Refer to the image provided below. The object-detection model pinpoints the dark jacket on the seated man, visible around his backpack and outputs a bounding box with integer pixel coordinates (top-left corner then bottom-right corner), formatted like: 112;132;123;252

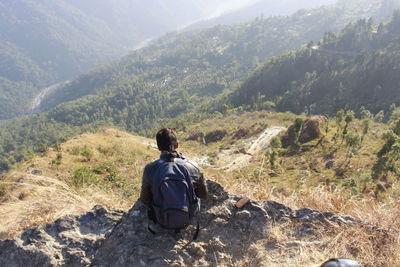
139;151;208;206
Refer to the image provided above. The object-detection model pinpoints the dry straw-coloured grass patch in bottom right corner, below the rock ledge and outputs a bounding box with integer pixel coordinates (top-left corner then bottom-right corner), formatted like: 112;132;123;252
238;223;399;267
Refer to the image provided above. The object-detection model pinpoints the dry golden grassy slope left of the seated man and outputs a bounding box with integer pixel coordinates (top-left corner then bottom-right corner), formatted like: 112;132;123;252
0;129;158;239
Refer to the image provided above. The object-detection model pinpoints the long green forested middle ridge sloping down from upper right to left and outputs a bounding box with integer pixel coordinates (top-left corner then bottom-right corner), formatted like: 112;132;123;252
0;0;398;172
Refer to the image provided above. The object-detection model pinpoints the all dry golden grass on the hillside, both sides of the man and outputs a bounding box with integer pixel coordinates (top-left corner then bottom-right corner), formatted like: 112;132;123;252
0;112;400;266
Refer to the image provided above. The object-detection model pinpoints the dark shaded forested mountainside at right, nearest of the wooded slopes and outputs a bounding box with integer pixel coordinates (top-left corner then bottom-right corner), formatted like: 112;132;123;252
228;11;400;114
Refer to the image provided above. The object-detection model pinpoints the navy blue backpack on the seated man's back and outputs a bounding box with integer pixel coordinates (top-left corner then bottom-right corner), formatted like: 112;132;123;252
152;158;200;230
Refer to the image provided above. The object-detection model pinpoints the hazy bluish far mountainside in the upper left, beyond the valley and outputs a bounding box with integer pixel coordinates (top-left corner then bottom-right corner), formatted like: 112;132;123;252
0;0;230;119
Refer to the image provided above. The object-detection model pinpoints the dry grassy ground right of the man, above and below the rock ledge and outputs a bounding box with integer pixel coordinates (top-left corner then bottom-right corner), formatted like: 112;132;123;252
191;112;400;266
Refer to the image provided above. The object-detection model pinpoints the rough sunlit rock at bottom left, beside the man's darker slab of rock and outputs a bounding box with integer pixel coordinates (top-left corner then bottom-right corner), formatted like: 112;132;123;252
0;206;123;267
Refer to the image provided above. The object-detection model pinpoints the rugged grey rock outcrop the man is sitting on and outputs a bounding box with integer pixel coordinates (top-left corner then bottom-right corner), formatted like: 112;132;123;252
0;181;356;266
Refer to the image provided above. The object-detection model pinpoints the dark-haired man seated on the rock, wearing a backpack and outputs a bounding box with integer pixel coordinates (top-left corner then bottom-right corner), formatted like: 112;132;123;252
140;128;207;231
